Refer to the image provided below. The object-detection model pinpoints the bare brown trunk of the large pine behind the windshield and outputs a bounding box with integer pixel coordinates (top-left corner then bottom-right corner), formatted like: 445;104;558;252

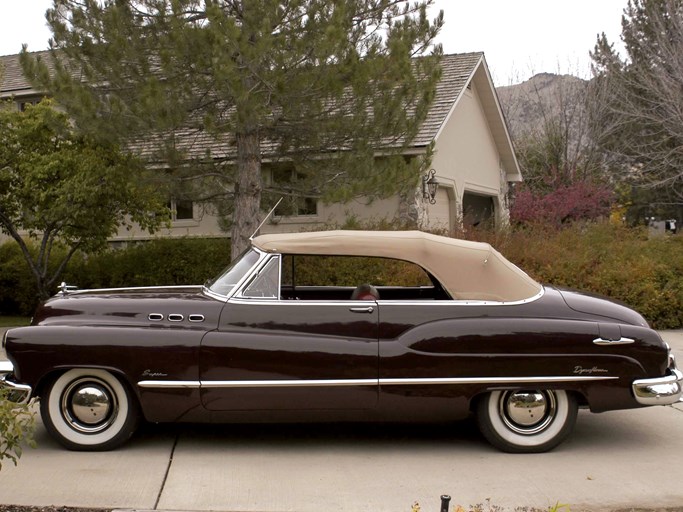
230;130;263;260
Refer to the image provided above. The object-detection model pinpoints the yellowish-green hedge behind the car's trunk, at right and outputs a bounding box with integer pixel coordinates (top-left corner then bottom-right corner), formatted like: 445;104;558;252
473;222;683;329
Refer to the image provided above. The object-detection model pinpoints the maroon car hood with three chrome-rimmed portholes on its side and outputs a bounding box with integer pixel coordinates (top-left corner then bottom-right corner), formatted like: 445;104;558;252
33;286;223;325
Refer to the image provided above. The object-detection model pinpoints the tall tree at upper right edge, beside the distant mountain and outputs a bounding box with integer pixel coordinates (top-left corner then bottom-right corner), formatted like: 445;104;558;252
591;0;683;215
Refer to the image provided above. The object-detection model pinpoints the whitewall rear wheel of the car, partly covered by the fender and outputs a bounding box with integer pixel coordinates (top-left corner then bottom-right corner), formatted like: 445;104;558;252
476;390;578;453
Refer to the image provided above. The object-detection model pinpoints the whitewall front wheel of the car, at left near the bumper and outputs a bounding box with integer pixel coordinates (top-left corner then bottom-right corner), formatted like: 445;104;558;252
40;368;139;451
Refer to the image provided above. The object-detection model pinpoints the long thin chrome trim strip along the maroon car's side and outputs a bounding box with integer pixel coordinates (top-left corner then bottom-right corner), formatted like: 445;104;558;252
138;375;619;389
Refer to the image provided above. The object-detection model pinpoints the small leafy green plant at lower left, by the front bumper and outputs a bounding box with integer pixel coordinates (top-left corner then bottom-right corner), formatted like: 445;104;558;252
0;389;35;469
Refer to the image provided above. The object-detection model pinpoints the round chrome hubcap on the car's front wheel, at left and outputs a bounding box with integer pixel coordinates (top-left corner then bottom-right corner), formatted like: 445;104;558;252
61;377;118;434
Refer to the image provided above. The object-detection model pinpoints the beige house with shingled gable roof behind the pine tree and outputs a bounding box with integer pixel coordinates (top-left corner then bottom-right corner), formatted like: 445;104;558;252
0;52;522;241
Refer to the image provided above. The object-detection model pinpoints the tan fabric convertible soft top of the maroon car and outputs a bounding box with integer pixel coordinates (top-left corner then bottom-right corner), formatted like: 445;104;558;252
252;231;542;302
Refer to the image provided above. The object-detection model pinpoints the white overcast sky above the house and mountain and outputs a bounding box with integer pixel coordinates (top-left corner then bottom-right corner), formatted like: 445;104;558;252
0;0;627;85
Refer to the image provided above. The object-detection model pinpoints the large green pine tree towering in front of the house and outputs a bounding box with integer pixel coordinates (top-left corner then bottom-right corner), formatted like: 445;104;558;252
22;0;443;256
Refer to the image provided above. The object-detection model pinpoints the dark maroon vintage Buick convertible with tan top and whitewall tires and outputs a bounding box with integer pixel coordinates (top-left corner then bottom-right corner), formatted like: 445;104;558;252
0;231;683;452
